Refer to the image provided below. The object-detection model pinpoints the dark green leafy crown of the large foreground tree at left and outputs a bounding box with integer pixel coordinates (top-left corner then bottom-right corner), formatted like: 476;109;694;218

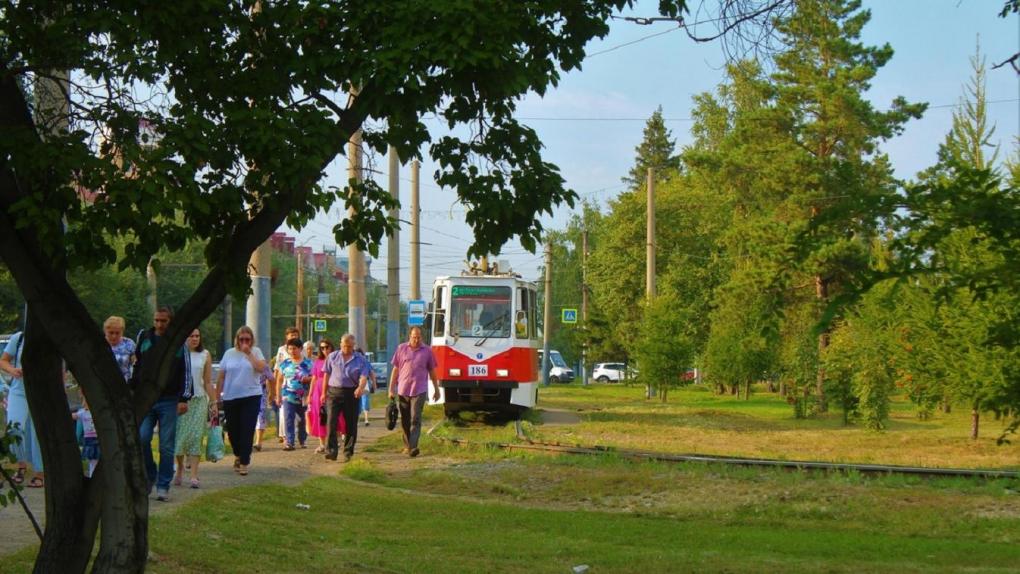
0;0;683;295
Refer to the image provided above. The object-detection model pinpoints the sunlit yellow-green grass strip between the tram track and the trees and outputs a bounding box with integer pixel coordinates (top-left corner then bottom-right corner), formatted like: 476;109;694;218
514;384;1020;470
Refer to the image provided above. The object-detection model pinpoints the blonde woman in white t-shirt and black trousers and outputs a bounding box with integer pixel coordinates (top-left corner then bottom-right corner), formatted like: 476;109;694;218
216;325;266;476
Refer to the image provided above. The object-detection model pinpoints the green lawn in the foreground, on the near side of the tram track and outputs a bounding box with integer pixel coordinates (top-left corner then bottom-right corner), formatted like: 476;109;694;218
0;448;1020;574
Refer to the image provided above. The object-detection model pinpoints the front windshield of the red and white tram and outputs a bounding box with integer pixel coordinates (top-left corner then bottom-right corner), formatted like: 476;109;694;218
450;285;512;338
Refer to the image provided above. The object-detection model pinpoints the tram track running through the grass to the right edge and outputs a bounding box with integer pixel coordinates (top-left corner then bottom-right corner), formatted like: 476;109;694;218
427;419;1020;479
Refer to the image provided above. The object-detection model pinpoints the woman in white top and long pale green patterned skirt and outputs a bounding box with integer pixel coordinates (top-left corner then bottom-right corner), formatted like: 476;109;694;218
173;329;216;488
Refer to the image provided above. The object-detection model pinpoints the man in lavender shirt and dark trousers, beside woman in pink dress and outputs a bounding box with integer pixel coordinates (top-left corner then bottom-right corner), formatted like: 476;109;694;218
320;333;372;462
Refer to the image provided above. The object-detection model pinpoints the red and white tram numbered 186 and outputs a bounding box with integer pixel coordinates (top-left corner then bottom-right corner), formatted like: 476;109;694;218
430;272;539;416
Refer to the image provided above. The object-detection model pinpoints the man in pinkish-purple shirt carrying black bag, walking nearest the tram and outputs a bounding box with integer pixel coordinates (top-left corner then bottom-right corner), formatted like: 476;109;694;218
390;327;440;457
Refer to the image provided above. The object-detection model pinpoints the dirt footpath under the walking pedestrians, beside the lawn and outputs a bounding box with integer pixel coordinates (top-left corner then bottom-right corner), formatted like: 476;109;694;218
0;405;579;557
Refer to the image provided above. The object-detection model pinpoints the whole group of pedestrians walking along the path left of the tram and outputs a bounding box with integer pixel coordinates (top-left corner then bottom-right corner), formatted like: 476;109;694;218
0;314;440;501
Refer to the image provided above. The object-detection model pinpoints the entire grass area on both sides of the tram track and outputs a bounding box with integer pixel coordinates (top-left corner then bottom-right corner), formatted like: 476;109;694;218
7;385;1020;574
